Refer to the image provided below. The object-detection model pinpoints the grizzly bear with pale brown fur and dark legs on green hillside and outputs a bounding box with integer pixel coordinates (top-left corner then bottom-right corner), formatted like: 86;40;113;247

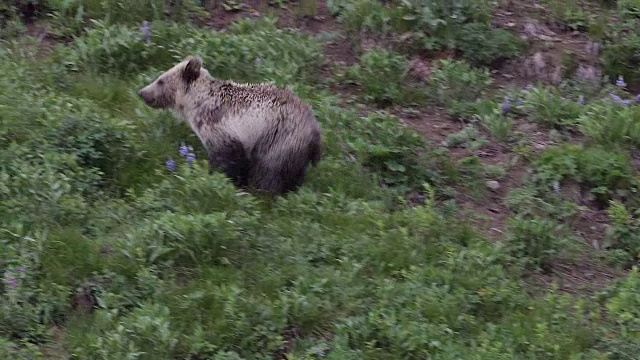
139;56;323;195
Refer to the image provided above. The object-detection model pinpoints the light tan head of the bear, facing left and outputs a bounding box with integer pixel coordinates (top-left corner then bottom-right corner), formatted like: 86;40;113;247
138;56;206;109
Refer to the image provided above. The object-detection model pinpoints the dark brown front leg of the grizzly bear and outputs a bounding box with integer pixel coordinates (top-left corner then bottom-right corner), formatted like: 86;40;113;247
208;138;250;188
